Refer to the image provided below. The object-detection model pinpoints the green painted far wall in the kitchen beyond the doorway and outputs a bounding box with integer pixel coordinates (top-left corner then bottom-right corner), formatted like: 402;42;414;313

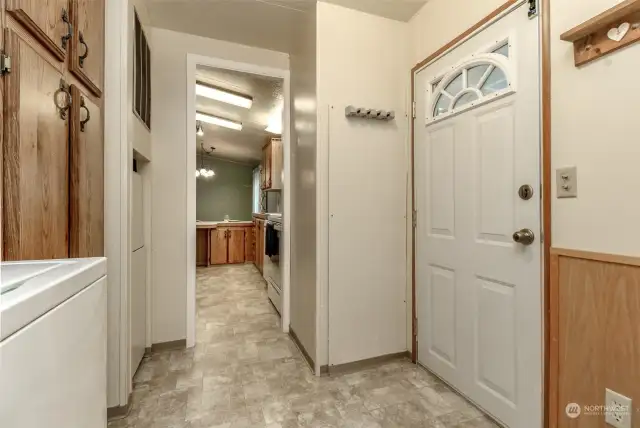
196;157;253;221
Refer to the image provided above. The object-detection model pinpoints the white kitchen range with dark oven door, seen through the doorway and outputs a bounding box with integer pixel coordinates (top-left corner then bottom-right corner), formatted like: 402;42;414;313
264;214;284;314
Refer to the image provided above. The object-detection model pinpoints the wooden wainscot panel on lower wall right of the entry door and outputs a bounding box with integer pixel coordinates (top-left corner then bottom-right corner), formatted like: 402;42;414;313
549;250;640;428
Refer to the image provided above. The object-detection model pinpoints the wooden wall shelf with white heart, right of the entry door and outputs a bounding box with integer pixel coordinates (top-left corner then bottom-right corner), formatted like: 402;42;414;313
560;0;640;67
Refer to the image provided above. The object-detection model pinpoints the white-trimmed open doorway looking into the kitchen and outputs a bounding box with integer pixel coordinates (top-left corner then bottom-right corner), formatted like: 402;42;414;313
185;54;291;347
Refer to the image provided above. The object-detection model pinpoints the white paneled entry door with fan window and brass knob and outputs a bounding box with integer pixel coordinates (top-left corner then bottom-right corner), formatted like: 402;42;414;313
414;3;543;428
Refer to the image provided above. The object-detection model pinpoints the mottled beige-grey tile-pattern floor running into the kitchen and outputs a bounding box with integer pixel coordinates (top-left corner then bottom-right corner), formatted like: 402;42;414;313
109;265;496;428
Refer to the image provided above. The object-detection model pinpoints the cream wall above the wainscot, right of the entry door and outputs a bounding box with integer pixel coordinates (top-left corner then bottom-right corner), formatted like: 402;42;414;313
551;0;640;256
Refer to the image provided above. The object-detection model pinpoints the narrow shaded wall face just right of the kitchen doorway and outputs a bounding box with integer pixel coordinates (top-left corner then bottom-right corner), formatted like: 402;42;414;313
290;8;318;363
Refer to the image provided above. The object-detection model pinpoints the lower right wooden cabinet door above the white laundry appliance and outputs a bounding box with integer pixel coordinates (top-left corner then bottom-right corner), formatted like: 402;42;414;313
69;85;104;257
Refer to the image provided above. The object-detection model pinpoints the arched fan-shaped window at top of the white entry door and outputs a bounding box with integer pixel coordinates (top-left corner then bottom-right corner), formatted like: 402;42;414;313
427;41;515;123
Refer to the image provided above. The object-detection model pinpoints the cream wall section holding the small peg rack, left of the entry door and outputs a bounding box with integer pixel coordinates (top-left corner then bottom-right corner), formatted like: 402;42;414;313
317;2;410;365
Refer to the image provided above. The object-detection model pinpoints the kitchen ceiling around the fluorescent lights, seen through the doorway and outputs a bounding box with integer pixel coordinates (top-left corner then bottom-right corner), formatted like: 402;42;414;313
196;67;284;165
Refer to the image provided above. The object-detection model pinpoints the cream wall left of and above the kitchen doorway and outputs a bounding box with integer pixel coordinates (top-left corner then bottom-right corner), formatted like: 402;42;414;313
148;28;289;343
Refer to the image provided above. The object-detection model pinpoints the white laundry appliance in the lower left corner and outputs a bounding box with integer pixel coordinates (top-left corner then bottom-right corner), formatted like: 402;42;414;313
0;257;107;428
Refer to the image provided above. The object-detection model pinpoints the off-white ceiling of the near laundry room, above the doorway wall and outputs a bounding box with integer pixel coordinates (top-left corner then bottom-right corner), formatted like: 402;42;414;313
147;0;426;52
